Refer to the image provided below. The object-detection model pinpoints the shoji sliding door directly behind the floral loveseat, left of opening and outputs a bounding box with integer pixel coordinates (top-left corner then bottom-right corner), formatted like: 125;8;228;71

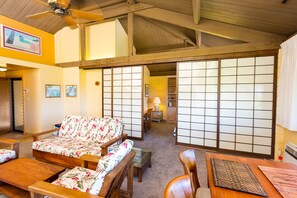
103;66;143;138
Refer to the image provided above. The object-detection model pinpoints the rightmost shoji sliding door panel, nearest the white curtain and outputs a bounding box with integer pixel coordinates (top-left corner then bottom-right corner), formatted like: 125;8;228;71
219;56;274;155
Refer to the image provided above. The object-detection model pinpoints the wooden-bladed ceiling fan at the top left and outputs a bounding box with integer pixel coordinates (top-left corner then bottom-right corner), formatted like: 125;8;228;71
26;0;104;29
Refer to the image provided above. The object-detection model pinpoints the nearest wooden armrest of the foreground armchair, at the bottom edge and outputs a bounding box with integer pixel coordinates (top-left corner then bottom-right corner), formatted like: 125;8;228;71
28;181;101;198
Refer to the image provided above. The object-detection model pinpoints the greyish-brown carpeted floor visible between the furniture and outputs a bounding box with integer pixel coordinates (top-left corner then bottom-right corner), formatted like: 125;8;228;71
0;122;207;198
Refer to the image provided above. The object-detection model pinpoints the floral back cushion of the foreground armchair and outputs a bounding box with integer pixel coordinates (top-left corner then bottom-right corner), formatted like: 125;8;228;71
90;139;134;195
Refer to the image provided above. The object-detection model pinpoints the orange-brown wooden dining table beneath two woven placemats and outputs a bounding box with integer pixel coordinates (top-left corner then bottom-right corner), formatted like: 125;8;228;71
205;152;297;198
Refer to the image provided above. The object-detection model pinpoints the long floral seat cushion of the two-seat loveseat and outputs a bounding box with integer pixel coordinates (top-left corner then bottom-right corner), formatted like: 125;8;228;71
32;137;101;158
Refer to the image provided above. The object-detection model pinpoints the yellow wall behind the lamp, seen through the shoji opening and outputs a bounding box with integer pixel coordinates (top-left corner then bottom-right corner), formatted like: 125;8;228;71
149;76;168;119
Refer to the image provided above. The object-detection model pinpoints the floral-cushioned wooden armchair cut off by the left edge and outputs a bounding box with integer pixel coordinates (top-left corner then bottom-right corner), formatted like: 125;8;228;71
0;138;20;164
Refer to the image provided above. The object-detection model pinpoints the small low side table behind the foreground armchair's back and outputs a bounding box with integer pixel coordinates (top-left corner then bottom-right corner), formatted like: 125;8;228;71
133;148;152;183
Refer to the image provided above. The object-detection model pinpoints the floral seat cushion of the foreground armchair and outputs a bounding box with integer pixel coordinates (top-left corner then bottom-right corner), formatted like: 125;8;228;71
52;167;95;192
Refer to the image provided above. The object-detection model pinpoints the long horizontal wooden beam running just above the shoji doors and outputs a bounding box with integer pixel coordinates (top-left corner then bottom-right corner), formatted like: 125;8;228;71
57;42;280;69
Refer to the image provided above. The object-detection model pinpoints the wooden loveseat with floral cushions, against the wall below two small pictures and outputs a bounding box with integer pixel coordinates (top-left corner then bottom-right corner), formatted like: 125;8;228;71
32;115;126;168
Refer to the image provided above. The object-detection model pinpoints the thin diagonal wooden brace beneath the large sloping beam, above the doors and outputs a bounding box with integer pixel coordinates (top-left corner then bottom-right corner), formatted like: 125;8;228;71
145;18;196;46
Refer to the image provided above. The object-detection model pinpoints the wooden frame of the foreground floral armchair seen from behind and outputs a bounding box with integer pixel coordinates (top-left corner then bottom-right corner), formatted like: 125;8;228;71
28;150;136;198
